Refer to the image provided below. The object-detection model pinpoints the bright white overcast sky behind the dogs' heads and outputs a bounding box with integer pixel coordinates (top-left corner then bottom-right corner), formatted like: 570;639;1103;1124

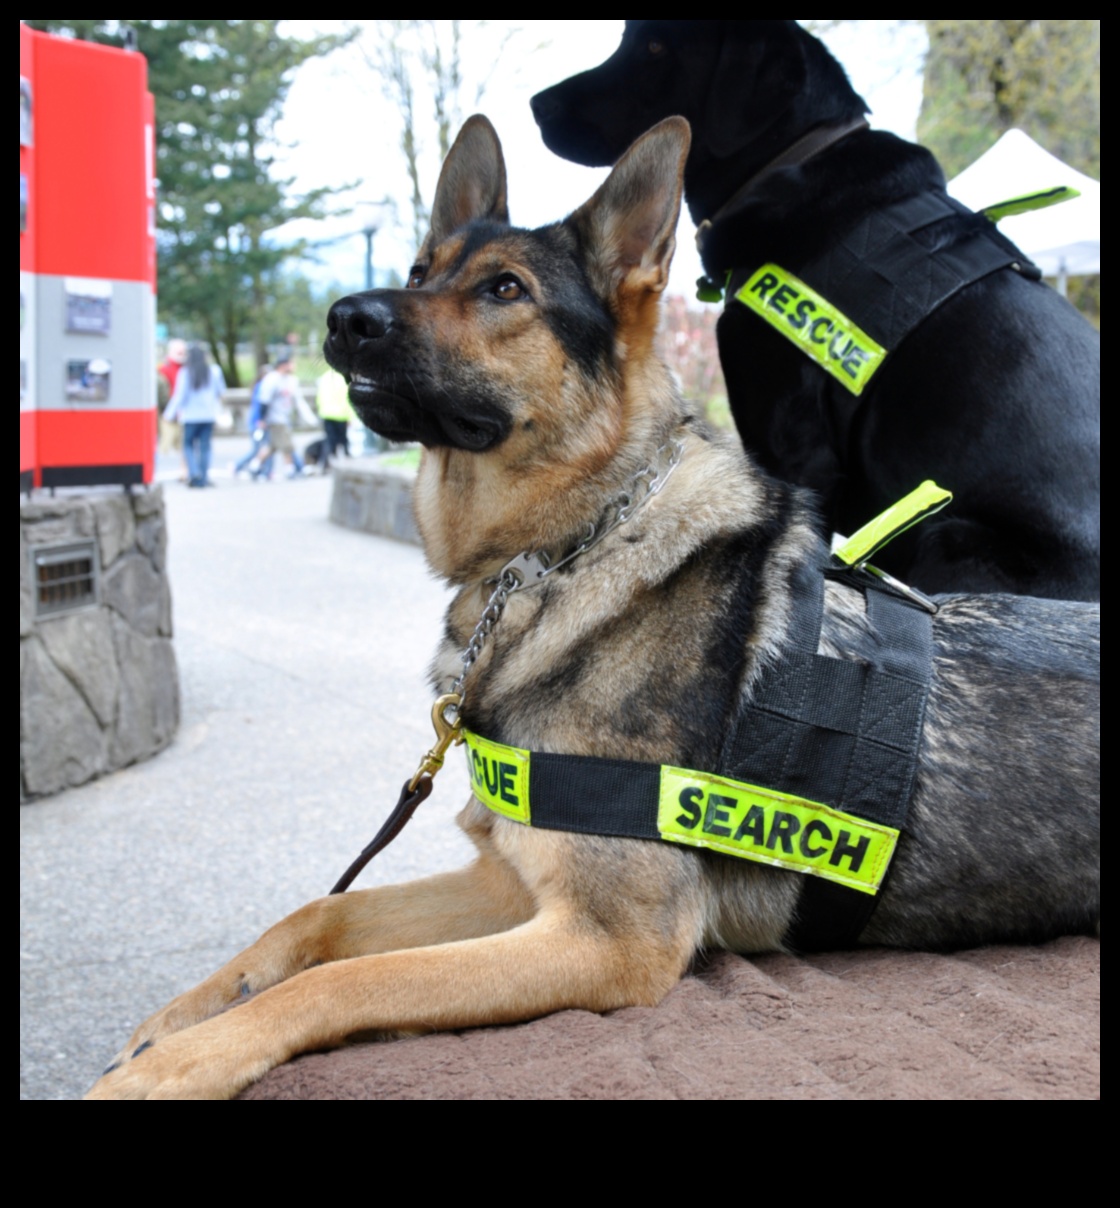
277;21;925;296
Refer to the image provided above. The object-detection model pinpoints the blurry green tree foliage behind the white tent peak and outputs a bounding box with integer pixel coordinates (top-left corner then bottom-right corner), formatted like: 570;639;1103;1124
918;21;1101;326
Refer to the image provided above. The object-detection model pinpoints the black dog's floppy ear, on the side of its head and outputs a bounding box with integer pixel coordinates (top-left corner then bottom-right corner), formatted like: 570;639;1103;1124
704;21;808;158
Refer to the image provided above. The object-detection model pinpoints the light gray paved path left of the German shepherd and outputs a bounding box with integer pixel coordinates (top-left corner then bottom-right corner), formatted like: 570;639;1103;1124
19;439;470;1099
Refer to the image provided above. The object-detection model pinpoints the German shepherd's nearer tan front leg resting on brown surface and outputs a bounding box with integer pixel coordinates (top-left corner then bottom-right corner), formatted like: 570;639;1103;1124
88;905;692;1099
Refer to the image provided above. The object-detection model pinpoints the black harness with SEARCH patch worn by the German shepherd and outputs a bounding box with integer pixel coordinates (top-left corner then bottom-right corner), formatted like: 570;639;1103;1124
464;484;948;951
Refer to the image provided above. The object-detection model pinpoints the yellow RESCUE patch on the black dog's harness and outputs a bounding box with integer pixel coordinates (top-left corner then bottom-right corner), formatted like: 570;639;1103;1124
735;265;887;395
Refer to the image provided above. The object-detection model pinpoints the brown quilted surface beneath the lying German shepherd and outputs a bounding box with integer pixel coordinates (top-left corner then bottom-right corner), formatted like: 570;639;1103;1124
242;936;1101;1099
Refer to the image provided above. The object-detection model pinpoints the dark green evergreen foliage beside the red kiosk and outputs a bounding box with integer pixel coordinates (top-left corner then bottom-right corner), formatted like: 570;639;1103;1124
28;21;347;385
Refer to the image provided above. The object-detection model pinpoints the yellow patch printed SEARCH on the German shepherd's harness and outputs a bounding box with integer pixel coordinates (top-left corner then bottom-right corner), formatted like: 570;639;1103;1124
657;767;899;894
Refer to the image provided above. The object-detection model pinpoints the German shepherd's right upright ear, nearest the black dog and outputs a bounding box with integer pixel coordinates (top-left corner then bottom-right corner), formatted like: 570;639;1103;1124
568;117;692;297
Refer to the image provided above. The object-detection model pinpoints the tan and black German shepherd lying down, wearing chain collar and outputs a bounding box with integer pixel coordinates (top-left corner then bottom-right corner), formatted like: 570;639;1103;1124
91;117;1099;1098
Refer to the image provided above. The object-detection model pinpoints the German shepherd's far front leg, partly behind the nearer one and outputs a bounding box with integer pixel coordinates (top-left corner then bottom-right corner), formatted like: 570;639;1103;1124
94;853;535;1070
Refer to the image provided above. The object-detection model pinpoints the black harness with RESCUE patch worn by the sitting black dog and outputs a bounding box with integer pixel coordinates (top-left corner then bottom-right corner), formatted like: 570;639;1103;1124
708;190;1064;395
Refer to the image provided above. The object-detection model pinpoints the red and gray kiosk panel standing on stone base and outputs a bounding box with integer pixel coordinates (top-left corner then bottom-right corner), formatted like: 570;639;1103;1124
19;25;156;490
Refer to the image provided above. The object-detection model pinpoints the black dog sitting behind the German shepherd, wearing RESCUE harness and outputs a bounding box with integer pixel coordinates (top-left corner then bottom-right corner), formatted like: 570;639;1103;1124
533;21;1101;599
